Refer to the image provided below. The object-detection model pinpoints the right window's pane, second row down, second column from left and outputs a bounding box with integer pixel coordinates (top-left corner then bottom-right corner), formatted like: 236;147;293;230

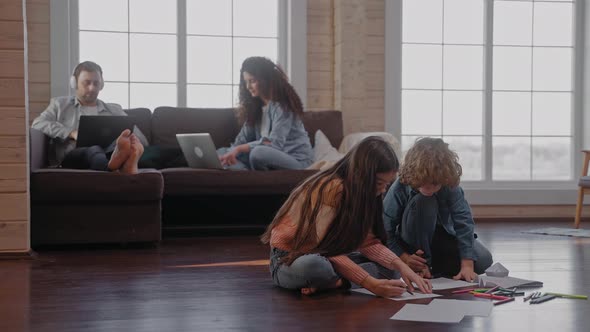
443;45;483;90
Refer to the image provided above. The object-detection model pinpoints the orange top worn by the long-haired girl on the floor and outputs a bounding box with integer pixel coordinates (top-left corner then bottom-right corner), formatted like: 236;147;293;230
270;180;399;285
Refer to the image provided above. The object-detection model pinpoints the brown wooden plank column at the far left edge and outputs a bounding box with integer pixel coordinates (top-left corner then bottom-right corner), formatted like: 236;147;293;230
0;0;30;253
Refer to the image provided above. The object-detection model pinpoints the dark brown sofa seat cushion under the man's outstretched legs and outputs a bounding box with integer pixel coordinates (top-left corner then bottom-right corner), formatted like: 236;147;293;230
31;168;164;203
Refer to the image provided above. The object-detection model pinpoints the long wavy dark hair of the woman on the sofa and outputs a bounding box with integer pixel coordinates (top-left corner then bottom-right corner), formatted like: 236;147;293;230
239;56;303;126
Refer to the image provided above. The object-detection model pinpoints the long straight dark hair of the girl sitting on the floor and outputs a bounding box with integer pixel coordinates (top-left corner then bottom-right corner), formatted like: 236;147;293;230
261;136;399;264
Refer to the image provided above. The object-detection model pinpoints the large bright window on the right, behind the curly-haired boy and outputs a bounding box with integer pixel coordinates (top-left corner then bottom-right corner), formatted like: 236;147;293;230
399;0;575;183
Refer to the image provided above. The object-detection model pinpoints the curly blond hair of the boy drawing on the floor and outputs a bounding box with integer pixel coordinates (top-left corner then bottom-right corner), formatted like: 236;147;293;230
399;137;463;189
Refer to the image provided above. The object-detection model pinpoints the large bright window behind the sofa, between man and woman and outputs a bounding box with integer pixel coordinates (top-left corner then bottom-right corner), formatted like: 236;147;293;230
78;0;279;110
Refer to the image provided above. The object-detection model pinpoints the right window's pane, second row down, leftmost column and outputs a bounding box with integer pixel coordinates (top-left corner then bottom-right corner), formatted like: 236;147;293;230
402;45;442;89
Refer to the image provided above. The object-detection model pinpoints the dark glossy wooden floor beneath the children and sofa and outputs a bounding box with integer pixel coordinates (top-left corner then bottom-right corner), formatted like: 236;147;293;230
0;222;590;332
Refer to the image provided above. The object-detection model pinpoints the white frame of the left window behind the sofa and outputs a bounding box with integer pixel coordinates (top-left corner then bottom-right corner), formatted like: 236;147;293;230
50;0;307;111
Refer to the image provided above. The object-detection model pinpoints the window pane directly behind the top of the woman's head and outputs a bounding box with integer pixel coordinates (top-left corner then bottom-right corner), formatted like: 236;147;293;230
232;38;278;84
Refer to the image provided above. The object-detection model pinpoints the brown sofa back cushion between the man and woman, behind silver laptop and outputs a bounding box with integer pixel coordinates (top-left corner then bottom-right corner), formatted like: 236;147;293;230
152;107;240;148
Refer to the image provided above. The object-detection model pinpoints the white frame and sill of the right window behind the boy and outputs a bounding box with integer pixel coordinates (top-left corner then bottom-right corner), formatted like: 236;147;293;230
385;0;590;205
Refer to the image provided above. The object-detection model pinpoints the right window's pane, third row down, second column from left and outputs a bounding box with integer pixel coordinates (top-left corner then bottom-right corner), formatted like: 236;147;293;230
443;91;483;135
